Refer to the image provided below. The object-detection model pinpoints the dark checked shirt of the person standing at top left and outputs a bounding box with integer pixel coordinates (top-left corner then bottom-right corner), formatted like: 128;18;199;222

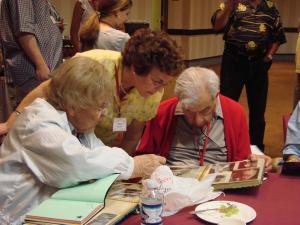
0;0;62;86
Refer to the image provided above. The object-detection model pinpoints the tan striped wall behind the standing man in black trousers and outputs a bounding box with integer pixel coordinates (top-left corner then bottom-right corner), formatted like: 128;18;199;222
168;0;300;60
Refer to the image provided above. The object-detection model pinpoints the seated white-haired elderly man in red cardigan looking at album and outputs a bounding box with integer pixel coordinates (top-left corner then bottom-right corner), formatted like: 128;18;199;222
134;67;272;170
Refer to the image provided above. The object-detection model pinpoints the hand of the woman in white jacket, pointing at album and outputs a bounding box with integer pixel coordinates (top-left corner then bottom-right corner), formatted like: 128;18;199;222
131;154;166;178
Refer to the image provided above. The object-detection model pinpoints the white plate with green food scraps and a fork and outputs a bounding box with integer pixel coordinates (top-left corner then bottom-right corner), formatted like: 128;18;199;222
195;201;256;224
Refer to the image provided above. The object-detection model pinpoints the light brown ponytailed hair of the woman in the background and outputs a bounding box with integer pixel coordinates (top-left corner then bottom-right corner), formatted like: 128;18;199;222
79;0;132;51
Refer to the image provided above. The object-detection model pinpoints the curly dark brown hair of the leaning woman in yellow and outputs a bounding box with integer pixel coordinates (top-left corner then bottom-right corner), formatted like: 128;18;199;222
122;28;185;76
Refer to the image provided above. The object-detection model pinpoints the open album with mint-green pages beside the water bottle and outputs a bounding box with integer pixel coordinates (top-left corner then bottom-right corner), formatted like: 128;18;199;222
25;174;142;225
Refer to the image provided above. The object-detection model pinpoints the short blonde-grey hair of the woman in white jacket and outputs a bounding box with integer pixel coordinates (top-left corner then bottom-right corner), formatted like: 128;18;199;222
45;56;113;111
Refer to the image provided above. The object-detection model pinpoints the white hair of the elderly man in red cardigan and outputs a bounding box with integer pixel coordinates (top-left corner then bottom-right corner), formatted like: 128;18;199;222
175;67;220;108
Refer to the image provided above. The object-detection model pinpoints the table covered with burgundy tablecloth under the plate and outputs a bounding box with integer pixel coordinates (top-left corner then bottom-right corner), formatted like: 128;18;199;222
120;173;300;225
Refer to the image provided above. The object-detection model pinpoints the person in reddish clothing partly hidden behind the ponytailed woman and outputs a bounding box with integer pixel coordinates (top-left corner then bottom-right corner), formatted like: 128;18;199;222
70;0;102;52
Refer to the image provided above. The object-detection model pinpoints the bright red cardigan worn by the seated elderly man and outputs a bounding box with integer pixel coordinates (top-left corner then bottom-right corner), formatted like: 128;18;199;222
134;95;251;161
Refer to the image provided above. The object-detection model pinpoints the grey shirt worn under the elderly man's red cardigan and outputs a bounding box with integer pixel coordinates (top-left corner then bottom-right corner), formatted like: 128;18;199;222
167;98;227;166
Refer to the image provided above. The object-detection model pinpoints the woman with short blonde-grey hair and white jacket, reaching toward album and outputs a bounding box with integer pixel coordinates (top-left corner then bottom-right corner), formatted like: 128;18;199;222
0;57;165;225
